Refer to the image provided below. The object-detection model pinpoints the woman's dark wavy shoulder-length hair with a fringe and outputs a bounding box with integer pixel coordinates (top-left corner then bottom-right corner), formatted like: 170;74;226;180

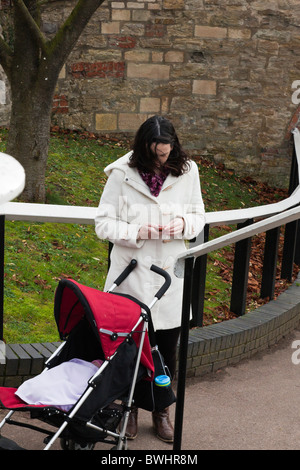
129;116;189;176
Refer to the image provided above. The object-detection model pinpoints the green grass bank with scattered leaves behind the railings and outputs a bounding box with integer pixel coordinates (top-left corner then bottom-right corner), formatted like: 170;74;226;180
0;129;286;343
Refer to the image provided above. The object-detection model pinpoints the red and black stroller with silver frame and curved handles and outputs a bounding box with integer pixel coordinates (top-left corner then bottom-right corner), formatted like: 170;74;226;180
0;260;171;450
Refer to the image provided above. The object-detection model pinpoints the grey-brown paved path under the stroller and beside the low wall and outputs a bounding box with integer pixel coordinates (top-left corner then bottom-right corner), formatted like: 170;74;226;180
0;330;300;451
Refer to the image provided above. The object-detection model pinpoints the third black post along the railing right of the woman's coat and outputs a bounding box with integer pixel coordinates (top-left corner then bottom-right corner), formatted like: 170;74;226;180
260;227;280;300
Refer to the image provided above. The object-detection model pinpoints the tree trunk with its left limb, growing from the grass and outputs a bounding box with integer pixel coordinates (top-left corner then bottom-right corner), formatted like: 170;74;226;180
6;1;57;203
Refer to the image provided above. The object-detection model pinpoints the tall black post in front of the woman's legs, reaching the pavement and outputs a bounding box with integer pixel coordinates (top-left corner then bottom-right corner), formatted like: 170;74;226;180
173;258;194;450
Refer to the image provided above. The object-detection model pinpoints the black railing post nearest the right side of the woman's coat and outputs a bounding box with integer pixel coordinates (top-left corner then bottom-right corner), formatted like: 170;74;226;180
191;224;209;326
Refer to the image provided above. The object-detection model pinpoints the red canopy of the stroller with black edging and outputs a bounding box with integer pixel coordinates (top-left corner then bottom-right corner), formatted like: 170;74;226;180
54;279;154;372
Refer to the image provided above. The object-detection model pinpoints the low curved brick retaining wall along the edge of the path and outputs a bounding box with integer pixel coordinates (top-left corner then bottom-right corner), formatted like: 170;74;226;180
0;273;300;387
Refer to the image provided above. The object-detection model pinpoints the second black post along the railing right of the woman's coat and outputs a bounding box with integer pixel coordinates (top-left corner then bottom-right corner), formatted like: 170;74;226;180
230;219;253;316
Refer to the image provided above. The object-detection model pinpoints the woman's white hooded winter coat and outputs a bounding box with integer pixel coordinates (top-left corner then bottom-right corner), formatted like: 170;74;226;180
95;152;205;330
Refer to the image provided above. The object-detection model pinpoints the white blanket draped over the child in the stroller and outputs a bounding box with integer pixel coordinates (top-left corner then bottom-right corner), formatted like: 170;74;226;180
16;359;98;411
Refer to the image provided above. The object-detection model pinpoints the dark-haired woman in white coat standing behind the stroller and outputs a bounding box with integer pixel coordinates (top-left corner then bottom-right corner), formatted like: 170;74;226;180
95;116;205;442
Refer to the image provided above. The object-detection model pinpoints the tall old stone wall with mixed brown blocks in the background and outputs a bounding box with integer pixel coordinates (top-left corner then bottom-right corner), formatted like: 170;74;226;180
0;0;300;185
